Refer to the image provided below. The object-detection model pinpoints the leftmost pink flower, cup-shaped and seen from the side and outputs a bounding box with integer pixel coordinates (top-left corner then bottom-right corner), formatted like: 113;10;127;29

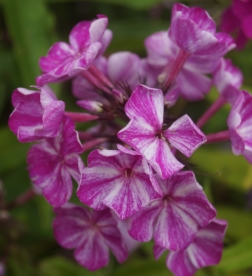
9;86;65;142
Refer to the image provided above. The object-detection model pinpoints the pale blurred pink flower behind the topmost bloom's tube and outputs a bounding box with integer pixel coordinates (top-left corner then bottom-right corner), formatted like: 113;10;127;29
145;31;218;100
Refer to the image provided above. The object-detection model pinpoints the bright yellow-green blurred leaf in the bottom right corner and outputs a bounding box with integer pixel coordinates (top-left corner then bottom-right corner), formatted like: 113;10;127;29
216;236;252;272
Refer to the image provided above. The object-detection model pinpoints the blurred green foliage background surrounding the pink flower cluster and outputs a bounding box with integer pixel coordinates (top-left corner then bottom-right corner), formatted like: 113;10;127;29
0;0;252;276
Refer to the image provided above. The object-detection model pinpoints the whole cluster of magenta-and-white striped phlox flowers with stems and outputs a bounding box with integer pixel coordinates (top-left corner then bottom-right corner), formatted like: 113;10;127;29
9;3;252;276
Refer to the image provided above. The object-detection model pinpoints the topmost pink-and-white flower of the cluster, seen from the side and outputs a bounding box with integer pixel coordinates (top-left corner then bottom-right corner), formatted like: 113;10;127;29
168;3;235;59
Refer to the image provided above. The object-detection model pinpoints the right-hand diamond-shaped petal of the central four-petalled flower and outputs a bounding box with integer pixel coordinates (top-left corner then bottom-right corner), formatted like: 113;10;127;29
164;115;206;157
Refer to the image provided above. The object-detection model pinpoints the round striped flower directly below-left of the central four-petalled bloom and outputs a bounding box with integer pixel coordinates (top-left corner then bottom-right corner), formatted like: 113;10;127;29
77;147;160;219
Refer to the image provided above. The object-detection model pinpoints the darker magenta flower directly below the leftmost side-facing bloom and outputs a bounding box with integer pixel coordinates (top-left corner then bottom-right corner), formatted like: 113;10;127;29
27;116;84;207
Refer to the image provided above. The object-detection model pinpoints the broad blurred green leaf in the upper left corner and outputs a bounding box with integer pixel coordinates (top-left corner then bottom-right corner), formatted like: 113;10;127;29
3;0;55;86
